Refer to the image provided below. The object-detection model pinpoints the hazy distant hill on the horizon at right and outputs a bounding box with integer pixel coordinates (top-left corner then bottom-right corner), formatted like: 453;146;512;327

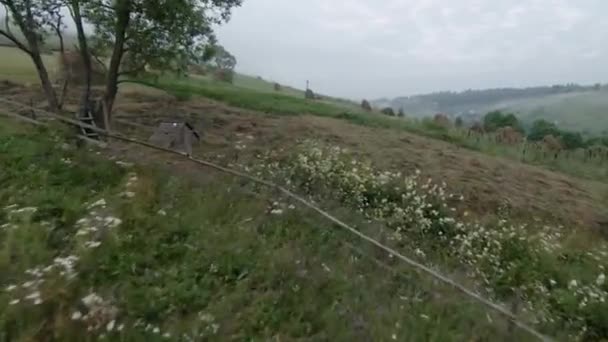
373;84;608;134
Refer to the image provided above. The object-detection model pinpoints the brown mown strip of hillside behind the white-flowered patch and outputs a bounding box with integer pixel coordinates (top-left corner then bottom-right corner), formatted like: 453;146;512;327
4;82;608;229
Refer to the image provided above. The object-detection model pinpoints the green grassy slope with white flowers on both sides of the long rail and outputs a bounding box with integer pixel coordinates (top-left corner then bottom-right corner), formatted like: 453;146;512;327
0;119;608;341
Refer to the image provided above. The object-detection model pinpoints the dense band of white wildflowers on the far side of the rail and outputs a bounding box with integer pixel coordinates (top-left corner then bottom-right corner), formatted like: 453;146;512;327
253;141;608;340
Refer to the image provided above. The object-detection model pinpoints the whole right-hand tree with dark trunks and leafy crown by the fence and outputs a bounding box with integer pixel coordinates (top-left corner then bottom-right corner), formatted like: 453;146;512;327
64;0;242;127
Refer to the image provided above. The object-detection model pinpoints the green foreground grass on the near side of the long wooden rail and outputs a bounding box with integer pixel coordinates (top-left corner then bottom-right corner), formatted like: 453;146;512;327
0;119;528;341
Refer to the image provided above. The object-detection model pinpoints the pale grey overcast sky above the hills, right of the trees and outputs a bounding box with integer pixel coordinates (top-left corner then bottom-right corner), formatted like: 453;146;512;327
218;0;608;99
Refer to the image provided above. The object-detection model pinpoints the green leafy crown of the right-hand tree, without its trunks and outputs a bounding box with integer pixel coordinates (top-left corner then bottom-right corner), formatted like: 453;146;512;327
82;0;242;74
